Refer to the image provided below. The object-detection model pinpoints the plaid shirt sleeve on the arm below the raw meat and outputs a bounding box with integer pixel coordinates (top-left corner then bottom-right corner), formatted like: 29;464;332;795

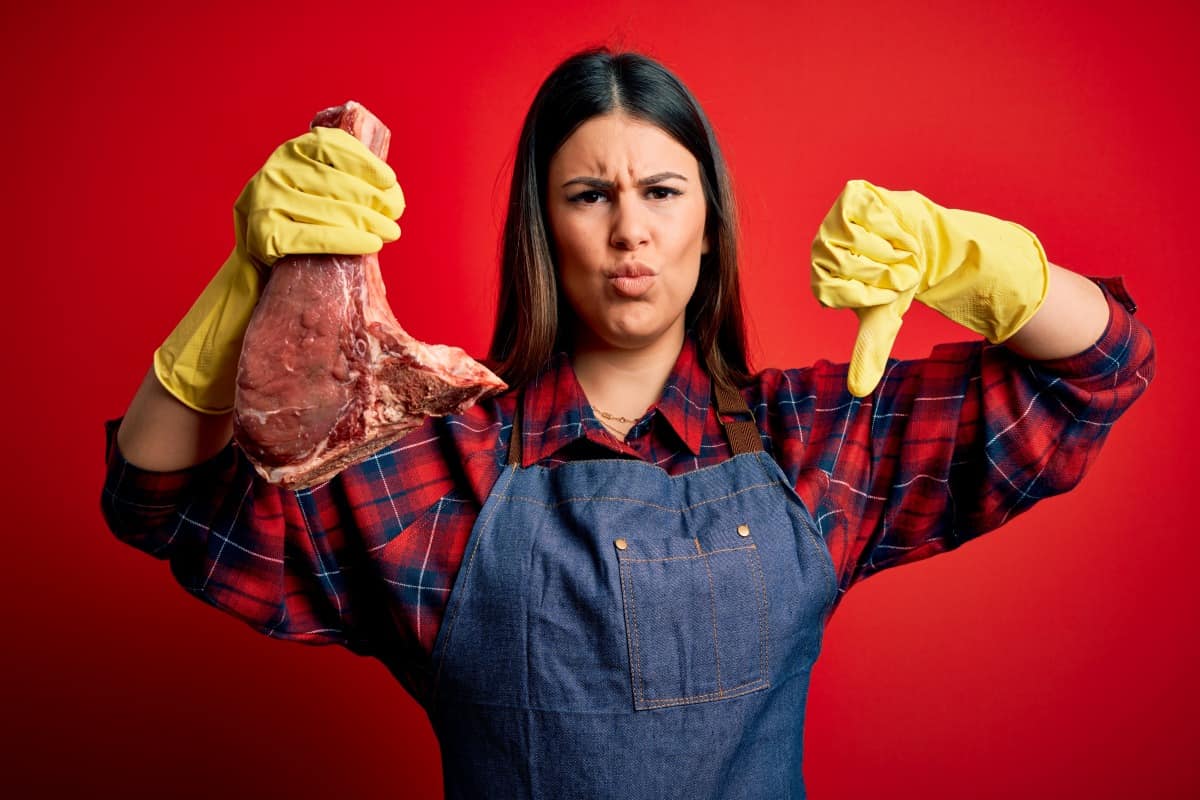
101;407;499;687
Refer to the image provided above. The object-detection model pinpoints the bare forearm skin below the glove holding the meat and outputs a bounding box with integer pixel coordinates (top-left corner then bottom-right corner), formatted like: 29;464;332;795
116;369;233;471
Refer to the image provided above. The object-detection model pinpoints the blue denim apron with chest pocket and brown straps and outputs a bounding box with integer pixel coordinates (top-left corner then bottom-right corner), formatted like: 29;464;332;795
427;390;836;800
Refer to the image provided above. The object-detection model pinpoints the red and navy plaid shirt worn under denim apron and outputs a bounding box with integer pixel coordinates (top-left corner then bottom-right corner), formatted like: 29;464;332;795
102;278;1154;699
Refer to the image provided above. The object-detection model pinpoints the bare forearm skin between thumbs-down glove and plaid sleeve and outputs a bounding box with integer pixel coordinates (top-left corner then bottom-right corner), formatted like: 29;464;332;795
1004;264;1109;361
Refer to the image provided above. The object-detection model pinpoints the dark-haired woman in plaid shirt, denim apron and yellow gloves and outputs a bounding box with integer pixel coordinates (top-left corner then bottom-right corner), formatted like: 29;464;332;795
103;50;1153;798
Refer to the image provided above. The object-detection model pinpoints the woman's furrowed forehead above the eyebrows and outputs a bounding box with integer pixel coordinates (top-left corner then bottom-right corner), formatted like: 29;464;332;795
550;113;700;180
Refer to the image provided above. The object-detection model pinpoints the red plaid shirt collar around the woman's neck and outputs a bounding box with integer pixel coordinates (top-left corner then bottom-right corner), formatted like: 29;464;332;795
521;335;712;467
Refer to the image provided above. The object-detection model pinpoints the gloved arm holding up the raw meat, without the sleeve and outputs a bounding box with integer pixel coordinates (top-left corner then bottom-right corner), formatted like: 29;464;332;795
116;127;404;471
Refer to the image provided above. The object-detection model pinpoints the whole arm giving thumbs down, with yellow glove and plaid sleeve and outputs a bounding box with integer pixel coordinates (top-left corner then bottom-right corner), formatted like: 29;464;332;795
787;180;1154;590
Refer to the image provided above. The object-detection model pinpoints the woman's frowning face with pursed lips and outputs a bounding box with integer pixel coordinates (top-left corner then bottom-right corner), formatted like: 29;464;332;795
546;113;708;348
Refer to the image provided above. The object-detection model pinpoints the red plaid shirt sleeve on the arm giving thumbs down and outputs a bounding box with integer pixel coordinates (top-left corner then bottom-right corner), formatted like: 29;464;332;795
762;278;1154;606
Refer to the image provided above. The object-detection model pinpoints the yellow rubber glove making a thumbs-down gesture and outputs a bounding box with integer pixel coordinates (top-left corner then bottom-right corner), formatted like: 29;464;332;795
812;180;1050;397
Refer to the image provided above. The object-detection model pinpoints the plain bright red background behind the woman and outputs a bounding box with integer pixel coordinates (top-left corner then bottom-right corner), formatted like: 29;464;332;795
0;0;1200;799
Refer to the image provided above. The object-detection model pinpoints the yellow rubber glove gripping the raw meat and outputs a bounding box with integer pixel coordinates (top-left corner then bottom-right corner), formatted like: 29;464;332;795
154;128;404;414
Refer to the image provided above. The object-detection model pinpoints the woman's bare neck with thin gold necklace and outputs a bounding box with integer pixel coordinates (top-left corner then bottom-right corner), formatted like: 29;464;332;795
571;326;684;427
